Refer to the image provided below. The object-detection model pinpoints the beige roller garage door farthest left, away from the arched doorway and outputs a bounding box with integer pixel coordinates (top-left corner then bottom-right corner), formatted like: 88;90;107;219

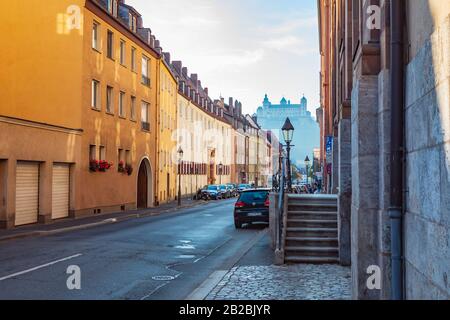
15;162;39;226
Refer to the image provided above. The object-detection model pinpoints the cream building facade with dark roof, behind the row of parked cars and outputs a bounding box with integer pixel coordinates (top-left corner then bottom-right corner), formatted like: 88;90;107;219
172;61;233;196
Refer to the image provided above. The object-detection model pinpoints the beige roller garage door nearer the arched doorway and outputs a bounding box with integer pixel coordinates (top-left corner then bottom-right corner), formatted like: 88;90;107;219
52;164;70;219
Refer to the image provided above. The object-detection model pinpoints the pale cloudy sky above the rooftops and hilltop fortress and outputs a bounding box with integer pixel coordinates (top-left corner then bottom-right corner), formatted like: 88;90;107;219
126;0;320;116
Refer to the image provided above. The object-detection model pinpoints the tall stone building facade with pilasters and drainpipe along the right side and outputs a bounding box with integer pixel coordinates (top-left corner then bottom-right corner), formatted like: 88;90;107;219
318;0;450;299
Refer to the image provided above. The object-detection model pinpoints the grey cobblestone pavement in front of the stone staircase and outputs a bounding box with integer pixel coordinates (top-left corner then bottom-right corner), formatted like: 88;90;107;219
206;265;351;300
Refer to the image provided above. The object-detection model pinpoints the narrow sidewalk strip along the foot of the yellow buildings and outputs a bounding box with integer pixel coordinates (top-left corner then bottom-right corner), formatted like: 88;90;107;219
0;199;210;243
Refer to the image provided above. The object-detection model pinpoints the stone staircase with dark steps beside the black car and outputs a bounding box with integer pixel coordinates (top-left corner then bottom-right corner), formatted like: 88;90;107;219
284;195;339;264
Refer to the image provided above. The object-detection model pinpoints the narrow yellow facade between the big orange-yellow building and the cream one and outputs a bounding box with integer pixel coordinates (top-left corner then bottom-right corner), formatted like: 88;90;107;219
157;53;178;203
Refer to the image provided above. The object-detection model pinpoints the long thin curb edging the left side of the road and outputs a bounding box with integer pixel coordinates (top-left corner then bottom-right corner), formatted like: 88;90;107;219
0;202;209;243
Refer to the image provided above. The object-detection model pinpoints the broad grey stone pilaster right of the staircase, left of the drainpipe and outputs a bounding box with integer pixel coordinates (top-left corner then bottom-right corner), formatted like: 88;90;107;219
351;75;380;299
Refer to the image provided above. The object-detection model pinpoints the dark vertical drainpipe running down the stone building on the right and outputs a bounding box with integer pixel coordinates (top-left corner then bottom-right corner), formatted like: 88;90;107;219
389;0;405;300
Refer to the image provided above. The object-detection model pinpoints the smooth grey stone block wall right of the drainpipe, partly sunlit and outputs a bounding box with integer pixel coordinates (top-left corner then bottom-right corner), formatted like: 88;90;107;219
404;16;450;299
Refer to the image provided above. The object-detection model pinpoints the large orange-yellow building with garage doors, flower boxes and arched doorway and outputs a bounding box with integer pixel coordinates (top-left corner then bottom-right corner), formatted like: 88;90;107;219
0;0;159;228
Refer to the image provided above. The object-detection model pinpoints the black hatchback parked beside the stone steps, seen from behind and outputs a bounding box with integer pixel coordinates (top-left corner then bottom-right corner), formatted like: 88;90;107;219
234;189;270;229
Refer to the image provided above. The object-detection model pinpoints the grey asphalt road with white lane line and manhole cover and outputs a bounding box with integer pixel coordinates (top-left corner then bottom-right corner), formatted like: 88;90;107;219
0;200;269;300
